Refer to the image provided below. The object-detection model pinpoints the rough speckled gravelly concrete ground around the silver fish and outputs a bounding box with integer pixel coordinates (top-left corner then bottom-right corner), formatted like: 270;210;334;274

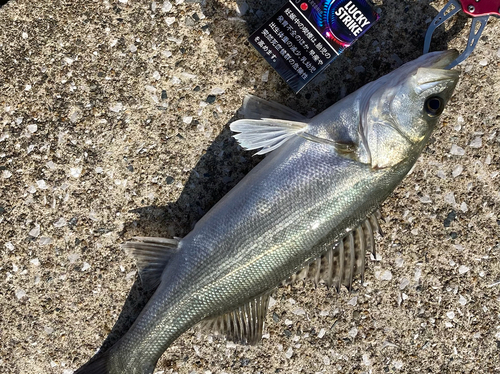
0;0;500;374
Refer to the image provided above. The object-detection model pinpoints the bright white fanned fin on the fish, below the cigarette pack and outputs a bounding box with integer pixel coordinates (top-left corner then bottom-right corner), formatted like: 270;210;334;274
230;118;307;155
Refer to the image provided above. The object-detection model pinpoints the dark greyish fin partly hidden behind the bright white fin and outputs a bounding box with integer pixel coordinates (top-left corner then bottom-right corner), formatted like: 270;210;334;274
240;95;308;123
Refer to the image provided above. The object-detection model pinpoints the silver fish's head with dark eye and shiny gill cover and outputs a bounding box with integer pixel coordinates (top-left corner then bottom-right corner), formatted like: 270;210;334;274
358;50;459;169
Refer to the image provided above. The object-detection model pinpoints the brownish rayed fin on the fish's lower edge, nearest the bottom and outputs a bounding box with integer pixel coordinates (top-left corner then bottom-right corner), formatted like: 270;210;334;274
199;292;271;345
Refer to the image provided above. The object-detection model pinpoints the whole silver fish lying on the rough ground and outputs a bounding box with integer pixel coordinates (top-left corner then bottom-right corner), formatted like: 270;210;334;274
76;50;459;374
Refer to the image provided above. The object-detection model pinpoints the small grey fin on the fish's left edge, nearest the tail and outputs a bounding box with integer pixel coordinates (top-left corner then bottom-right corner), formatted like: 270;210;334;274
122;237;179;289
